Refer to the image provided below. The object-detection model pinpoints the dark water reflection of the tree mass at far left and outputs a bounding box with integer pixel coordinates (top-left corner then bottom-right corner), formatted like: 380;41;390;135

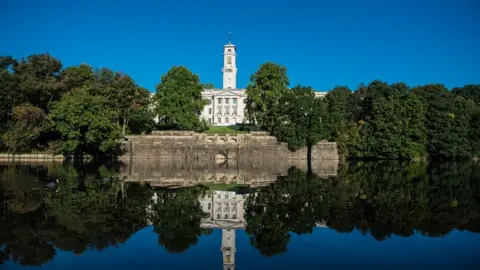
0;162;152;265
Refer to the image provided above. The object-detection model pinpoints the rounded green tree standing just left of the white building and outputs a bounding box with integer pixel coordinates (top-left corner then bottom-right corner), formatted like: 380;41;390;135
154;67;206;131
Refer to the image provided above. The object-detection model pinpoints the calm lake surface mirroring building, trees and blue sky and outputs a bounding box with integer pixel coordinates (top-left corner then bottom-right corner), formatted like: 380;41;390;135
0;161;480;270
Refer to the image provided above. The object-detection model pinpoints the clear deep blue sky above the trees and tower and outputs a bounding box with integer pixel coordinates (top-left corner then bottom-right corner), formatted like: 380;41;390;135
0;0;480;90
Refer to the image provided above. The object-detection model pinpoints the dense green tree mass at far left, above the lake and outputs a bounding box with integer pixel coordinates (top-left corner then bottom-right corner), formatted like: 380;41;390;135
0;54;153;155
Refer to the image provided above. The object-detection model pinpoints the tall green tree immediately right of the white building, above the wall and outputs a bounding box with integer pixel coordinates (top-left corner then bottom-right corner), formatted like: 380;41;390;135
245;62;289;132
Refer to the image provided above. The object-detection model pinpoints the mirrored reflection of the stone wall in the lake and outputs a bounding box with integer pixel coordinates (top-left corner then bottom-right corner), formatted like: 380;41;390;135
121;159;338;187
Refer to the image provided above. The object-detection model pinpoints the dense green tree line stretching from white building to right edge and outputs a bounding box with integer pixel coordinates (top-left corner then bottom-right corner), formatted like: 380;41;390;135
246;63;480;160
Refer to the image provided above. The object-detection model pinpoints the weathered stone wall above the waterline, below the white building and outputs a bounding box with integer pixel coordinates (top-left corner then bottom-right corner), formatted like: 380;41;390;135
122;131;338;160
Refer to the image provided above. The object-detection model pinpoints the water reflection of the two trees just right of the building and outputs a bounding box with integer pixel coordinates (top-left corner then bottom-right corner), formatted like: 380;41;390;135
245;168;322;256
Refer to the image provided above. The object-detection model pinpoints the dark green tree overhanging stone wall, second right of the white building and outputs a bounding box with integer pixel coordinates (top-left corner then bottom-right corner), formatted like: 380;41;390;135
273;86;330;167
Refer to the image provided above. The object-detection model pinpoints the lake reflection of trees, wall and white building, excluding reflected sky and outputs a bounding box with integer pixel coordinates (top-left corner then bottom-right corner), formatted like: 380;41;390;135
0;161;480;269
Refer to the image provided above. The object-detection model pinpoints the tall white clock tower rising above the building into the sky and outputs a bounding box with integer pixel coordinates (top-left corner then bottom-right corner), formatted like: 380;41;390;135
222;33;237;89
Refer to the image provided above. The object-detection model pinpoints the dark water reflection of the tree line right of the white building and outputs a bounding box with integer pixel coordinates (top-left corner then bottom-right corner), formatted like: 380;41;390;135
245;162;480;256
